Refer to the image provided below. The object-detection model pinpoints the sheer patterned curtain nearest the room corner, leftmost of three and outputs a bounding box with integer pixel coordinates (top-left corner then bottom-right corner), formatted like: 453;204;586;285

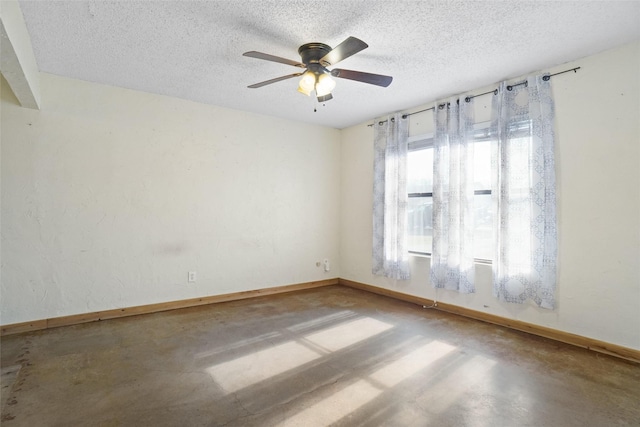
372;114;410;279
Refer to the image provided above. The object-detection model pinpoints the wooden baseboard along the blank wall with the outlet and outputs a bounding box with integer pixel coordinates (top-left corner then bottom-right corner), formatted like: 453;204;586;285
0;278;338;336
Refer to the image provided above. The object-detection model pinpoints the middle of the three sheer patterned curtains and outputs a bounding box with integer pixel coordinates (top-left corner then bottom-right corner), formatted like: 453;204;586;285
430;98;475;293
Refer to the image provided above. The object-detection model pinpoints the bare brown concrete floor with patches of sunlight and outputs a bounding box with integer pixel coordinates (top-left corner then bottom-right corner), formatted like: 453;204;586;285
1;286;640;427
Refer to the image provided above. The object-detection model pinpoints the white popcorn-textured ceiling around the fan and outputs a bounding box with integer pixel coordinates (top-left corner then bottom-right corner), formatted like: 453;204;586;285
15;0;640;129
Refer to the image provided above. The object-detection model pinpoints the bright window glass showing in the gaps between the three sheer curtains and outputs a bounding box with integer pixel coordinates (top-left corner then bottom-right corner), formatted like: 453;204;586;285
407;123;494;260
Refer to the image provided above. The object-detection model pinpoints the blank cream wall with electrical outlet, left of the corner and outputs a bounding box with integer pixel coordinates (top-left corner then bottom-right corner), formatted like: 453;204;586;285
0;74;340;324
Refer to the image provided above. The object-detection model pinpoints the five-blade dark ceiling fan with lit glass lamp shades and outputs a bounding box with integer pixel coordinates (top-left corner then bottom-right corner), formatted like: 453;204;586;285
243;37;393;102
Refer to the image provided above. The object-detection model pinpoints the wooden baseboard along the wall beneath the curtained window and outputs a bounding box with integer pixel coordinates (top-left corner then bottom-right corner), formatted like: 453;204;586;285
339;279;640;363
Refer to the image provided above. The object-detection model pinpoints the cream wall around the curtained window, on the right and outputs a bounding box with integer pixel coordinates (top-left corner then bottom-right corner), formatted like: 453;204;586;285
340;42;640;349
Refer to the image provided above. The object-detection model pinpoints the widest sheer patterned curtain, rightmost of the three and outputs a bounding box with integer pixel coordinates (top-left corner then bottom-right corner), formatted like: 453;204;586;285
491;76;558;309
